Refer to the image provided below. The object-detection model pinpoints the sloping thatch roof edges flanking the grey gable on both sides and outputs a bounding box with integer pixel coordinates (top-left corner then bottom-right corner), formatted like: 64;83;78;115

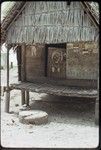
1;1;99;44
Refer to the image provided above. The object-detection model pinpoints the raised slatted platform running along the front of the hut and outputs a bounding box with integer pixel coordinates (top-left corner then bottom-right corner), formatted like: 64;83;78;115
10;82;97;98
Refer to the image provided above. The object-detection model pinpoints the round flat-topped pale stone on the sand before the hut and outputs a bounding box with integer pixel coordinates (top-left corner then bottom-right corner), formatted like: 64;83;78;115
19;110;48;125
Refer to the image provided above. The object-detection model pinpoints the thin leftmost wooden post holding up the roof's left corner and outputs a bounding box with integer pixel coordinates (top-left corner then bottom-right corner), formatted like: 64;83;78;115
5;46;10;113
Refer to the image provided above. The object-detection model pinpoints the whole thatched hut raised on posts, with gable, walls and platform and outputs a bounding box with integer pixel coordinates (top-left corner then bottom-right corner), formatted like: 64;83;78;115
1;1;99;123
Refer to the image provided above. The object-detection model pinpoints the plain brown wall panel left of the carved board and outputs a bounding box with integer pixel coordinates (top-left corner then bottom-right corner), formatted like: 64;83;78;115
25;44;45;81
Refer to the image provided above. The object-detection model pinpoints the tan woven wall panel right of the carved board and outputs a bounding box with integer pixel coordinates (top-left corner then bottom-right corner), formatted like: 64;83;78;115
66;42;99;80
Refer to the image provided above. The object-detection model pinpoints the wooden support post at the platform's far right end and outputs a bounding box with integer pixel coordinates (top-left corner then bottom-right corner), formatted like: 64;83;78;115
95;78;99;125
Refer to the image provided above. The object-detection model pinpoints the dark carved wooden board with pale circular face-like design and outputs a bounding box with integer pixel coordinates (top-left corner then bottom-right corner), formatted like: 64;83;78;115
48;47;66;79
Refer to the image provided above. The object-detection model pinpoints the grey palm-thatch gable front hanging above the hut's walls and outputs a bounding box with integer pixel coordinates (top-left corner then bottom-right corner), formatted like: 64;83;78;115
7;1;98;44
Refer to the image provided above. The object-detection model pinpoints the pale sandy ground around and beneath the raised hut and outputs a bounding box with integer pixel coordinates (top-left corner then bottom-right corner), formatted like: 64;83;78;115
1;68;99;148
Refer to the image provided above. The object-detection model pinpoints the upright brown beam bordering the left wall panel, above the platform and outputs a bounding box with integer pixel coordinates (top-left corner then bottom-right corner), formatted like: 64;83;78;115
21;44;26;81
